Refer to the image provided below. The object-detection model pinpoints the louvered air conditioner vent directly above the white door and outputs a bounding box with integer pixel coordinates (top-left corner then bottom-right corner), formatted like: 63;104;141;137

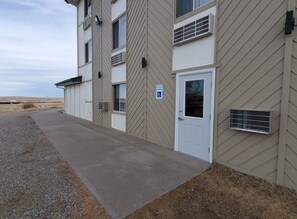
173;14;214;45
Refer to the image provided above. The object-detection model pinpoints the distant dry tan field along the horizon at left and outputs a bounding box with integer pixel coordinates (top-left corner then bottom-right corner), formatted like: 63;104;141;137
0;97;64;113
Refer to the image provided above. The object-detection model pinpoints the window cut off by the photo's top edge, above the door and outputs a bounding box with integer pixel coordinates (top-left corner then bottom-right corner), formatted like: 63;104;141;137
176;0;214;18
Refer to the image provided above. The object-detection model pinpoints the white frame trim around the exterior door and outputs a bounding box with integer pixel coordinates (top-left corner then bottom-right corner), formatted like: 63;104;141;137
174;68;216;163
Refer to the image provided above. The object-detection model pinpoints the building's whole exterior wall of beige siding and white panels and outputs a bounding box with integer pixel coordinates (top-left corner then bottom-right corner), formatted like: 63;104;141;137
65;0;297;189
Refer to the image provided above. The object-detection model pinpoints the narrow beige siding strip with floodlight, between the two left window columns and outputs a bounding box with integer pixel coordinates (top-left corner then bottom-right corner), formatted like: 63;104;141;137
92;1;113;128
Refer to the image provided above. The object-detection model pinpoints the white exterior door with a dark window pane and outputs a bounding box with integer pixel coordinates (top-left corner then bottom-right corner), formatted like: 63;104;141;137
177;72;212;161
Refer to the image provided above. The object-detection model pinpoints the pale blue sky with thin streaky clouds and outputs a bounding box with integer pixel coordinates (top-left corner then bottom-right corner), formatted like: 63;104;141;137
0;0;77;97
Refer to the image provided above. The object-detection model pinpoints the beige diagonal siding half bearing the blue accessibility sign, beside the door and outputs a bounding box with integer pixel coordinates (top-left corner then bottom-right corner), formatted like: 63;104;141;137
147;0;175;148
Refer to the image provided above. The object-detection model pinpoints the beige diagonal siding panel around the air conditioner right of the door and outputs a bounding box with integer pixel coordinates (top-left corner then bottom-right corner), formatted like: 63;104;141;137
216;0;287;182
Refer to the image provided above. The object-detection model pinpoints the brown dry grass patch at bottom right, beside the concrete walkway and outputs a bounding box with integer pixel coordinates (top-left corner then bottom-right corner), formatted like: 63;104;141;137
128;164;297;219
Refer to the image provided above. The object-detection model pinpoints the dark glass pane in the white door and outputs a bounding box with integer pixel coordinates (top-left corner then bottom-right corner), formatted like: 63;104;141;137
185;80;204;118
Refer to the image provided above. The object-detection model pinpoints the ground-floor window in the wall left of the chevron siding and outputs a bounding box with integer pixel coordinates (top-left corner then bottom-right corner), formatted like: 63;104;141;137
113;84;126;112
